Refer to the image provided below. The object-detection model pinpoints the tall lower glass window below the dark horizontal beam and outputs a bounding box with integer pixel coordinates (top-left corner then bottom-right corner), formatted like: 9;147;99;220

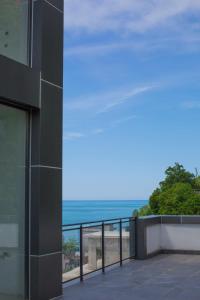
0;104;27;300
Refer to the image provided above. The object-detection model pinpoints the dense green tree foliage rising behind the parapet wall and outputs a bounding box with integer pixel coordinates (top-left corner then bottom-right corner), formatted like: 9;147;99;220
135;163;200;216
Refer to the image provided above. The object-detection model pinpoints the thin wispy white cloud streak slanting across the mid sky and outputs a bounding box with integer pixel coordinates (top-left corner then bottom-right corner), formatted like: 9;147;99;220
65;84;158;114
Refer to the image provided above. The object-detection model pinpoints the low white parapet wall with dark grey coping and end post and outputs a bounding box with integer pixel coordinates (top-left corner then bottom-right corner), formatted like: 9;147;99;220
137;216;200;259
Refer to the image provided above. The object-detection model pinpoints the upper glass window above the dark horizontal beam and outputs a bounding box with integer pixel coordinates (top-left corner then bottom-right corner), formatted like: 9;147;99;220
0;0;29;64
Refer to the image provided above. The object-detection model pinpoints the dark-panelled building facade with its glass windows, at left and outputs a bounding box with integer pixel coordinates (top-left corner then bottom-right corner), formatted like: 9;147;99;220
0;0;63;300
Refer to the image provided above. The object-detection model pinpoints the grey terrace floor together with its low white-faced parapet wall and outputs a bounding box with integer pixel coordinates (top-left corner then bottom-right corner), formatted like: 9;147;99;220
63;216;200;300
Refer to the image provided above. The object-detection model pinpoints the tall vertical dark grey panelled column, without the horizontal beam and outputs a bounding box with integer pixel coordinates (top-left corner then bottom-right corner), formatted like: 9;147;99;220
30;0;63;300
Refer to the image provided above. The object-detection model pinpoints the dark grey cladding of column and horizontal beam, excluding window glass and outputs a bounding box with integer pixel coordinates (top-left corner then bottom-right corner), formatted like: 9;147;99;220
0;0;64;300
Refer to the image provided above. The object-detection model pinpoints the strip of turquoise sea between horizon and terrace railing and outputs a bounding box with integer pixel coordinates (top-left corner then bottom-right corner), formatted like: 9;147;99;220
63;200;148;224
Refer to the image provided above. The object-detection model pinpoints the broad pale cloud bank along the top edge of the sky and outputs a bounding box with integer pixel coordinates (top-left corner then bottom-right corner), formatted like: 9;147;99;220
65;0;200;33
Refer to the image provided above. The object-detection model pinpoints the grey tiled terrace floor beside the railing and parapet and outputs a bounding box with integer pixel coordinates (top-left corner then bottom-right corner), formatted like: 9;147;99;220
64;254;200;300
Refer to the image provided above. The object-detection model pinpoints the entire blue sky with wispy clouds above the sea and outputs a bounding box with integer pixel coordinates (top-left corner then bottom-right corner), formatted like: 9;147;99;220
63;0;200;200
